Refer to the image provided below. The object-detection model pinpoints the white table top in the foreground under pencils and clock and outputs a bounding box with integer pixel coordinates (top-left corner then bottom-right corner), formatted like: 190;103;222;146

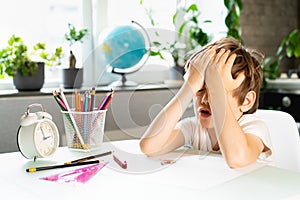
0;140;300;200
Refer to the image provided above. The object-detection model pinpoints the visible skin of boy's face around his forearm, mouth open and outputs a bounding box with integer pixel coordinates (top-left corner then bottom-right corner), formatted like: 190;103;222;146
194;87;243;128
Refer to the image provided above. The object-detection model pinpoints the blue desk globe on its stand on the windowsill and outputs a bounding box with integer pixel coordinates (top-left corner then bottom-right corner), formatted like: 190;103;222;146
101;22;150;86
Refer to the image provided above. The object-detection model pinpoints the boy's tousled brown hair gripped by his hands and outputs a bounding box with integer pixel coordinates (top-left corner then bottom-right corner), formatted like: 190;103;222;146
187;37;264;114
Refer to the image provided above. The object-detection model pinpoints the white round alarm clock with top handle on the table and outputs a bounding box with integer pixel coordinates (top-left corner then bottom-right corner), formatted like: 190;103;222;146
17;104;59;160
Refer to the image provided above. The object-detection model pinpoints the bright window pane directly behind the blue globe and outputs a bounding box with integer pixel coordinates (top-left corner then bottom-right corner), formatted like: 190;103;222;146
93;0;177;84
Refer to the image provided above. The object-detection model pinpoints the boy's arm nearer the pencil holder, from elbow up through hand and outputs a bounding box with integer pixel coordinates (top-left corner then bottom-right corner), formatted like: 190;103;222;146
140;51;207;156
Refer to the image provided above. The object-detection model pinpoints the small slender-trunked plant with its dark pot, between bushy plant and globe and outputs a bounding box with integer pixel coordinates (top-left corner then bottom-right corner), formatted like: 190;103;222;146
63;23;88;89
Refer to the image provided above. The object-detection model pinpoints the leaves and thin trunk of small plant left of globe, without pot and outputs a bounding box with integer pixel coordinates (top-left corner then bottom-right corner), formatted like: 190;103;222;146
64;23;88;68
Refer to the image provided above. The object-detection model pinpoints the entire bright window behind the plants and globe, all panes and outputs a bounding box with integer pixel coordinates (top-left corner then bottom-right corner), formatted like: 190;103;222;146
0;0;226;89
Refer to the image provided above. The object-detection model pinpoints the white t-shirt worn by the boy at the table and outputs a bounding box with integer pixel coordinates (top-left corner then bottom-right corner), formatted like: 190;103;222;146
176;114;273;161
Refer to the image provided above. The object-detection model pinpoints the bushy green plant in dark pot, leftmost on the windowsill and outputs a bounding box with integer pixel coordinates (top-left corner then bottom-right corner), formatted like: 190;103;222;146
0;35;62;91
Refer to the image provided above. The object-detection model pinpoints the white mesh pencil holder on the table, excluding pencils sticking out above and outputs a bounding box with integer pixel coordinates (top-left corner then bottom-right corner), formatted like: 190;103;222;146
61;110;106;150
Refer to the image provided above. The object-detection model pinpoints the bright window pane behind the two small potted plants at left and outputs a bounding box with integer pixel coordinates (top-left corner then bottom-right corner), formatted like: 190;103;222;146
0;0;83;89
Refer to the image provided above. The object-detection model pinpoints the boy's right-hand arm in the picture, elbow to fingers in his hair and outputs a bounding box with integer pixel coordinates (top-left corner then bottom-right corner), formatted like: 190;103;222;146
205;50;264;168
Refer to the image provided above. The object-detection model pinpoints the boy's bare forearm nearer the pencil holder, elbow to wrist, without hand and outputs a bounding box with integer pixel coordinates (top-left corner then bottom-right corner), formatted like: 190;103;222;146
140;84;193;156
